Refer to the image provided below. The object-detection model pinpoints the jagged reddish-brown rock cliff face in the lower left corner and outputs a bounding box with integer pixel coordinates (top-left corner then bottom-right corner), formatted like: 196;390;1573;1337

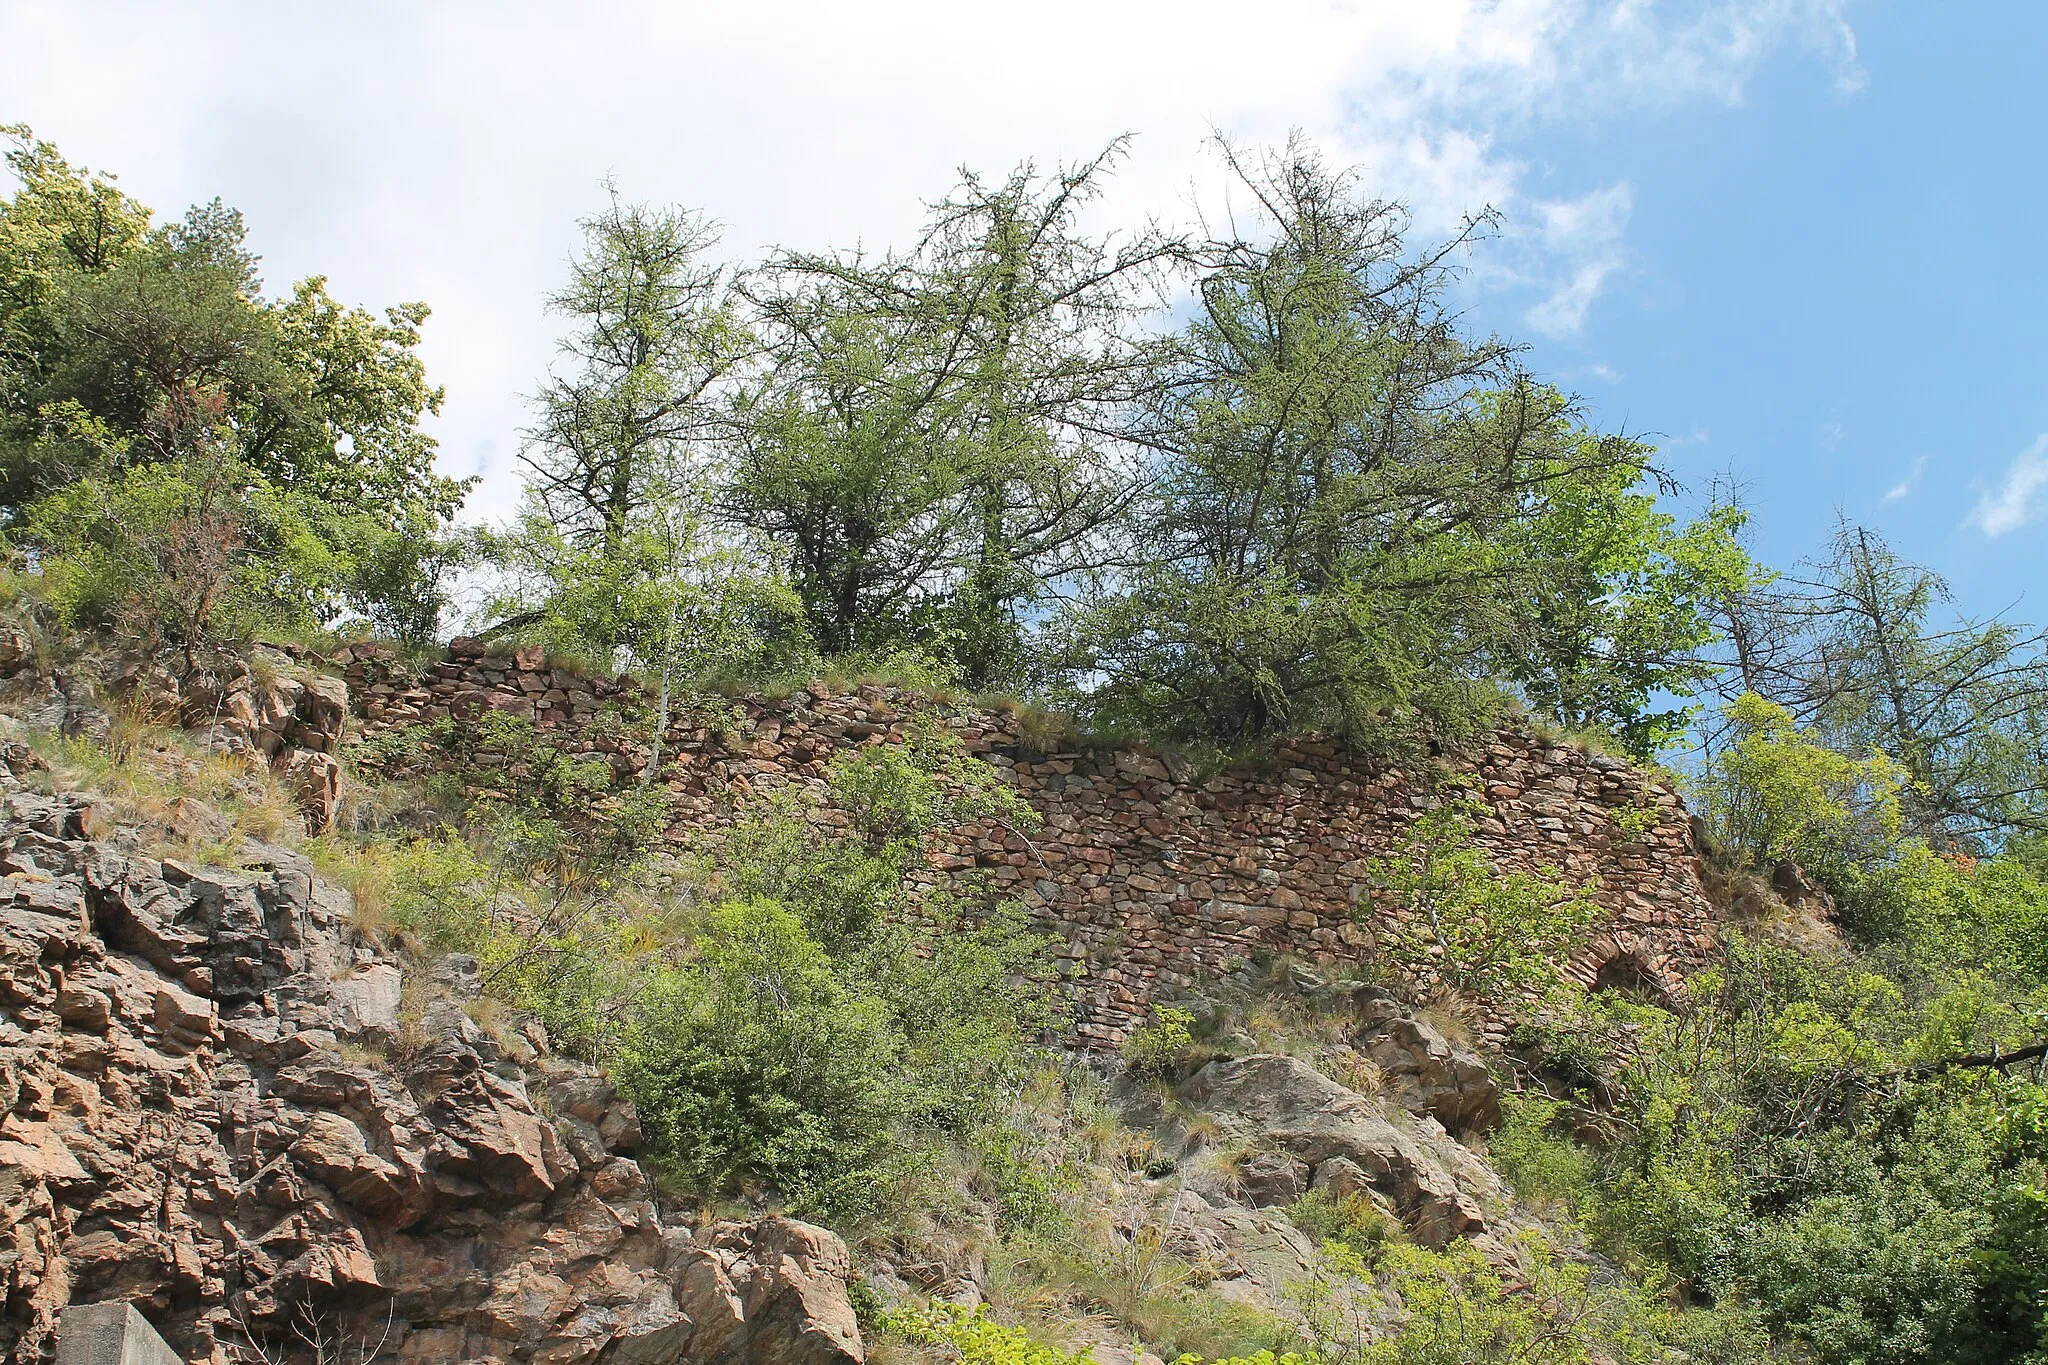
0;749;862;1365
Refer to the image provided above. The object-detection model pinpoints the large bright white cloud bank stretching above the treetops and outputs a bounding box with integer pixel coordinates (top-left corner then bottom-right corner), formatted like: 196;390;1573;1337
0;0;1855;516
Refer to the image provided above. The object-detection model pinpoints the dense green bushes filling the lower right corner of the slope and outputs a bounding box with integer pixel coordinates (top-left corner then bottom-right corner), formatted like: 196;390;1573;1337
1540;908;2048;1365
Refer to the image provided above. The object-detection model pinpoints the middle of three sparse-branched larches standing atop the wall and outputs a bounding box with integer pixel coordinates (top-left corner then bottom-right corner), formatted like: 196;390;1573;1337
725;141;1171;686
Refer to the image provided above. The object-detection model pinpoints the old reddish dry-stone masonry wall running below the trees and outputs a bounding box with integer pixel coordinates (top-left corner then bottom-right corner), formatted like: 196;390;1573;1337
334;641;1714;1048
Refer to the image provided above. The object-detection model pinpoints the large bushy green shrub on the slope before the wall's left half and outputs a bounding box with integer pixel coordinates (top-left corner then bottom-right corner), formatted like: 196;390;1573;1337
616;726;1053;1216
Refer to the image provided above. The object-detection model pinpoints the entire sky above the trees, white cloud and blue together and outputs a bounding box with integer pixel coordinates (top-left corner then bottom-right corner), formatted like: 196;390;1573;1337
0;0;2048;618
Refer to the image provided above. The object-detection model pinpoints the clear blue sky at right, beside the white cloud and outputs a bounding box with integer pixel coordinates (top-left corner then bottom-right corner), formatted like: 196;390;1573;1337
1501;4;2048;620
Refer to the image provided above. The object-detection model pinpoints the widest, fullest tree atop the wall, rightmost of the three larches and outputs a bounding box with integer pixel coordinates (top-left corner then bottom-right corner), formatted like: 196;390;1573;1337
1077;143;1720;745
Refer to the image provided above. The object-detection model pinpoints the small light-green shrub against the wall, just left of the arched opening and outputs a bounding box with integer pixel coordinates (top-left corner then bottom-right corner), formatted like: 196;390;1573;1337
1360;788;1599;1003
